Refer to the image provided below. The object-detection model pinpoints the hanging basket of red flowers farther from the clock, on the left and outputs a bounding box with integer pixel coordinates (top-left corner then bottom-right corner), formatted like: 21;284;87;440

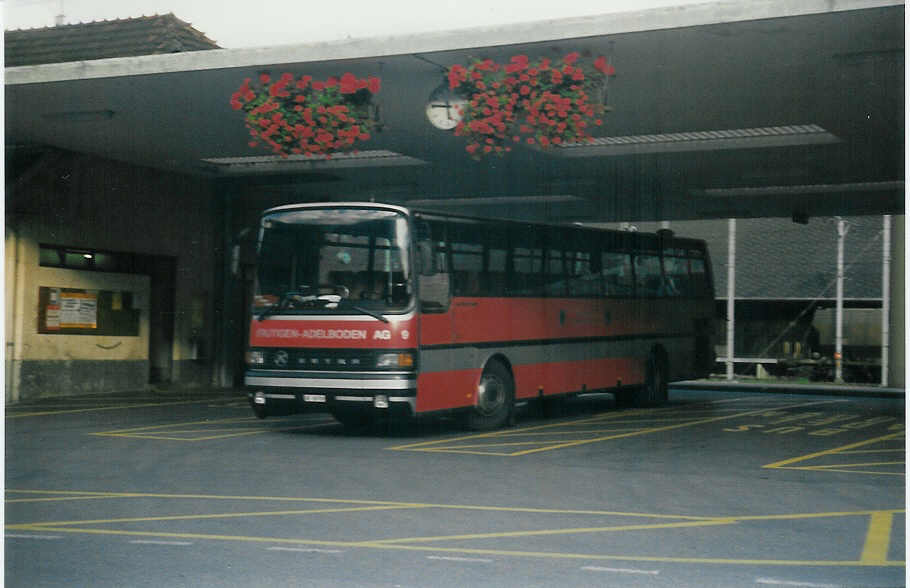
231;73;381;157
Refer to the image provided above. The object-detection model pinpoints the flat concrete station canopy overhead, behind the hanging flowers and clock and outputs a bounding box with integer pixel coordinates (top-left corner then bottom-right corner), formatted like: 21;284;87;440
5;0;905;222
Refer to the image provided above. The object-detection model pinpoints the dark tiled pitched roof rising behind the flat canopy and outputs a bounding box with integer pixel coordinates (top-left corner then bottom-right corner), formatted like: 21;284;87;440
4;13;220;67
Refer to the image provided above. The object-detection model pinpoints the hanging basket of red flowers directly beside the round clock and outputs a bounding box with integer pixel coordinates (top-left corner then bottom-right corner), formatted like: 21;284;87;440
448;52;615;159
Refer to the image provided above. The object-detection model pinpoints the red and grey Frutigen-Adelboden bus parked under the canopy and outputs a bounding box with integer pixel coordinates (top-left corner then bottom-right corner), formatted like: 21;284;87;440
245;203;715;429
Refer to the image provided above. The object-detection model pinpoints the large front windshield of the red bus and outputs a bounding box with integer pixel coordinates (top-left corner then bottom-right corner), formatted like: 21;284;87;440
253;208;414;320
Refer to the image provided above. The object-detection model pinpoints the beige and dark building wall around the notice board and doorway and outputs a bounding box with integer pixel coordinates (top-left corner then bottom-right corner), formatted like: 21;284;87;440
5;152;220;402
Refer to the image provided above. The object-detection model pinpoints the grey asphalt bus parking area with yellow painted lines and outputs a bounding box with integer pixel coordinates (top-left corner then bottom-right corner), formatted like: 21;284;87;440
5;390;906;586
